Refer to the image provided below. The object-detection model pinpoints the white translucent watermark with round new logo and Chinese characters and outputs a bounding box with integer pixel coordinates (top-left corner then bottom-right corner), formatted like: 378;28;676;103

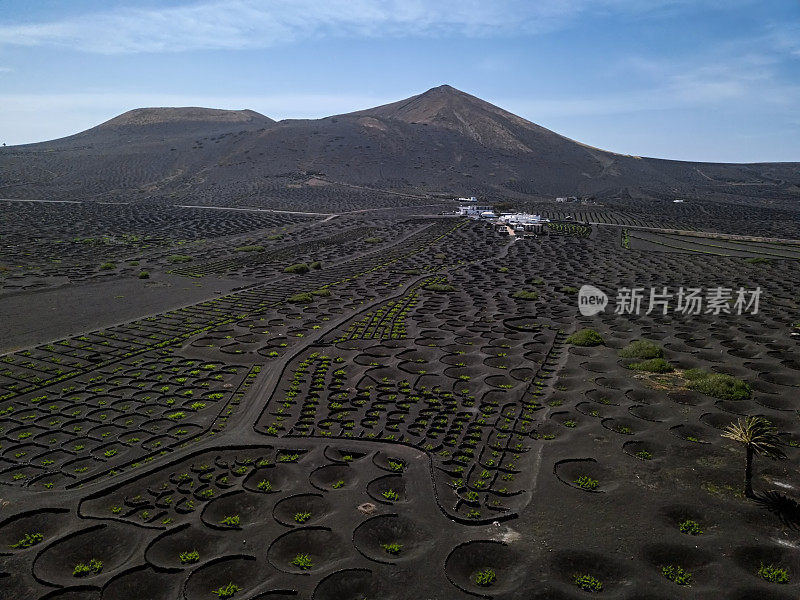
578;285;761;317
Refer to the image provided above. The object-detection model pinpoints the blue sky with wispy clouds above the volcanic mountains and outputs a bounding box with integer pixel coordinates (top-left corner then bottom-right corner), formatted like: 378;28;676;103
0;0;800;162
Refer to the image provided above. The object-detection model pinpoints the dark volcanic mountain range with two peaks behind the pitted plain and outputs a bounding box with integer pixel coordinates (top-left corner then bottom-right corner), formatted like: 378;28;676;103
0;85;800;204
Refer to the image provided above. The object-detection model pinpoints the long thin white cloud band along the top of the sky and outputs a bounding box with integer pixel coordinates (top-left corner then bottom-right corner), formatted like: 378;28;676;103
0;0;718;54
